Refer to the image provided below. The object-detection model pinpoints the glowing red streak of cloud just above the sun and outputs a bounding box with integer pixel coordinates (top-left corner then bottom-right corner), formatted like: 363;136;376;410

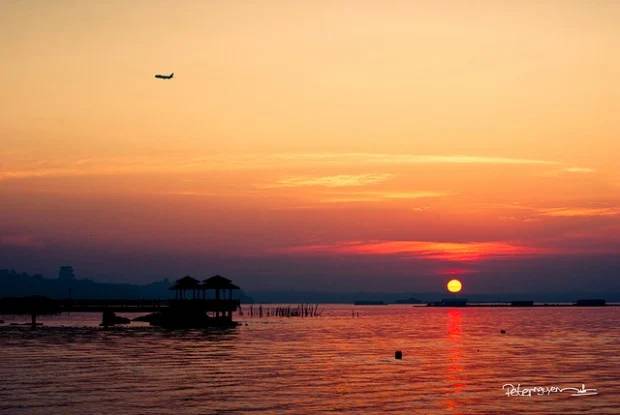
284;241;548;262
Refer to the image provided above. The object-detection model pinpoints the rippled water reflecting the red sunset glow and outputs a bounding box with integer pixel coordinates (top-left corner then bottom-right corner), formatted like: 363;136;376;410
0;306;620;414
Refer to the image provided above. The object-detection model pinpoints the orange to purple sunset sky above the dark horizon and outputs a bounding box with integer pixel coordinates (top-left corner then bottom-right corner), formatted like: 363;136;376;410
0;0;620;293
